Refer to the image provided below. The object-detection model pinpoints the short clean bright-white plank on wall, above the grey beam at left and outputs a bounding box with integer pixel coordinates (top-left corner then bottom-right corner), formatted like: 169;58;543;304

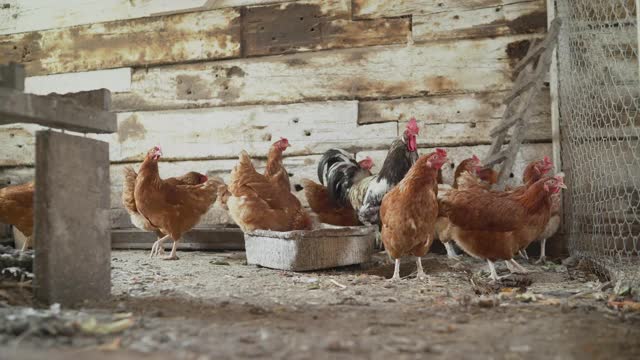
24;68;131;95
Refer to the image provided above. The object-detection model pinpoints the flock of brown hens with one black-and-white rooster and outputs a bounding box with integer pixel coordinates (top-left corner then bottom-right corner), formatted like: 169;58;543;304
0;119;566;280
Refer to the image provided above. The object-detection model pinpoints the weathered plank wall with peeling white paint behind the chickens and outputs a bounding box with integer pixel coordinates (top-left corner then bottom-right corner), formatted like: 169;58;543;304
0;0;551;227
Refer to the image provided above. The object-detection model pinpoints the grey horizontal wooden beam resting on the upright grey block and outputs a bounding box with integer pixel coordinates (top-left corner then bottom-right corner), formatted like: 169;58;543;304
0;88;116;134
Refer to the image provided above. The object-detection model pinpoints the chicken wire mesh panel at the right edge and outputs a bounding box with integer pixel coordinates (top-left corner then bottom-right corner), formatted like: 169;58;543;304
557;0;640;288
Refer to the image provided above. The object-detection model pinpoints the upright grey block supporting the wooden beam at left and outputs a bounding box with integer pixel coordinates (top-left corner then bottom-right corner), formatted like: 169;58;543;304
34;131;111;306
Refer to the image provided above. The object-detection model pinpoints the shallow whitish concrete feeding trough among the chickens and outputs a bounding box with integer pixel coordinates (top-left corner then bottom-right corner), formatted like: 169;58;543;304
244;224;375;271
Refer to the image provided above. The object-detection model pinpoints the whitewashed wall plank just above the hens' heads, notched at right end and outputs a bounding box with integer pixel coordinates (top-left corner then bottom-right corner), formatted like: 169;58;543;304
0;101;397;166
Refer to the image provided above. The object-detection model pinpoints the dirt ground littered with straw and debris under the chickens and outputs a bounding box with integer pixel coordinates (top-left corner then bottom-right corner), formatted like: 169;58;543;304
0;251;640;360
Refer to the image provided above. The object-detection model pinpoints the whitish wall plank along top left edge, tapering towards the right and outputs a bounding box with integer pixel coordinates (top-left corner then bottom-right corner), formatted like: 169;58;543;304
0;0;294;35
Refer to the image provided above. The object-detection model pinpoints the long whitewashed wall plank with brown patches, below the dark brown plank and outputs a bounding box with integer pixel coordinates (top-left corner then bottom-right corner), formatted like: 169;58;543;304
114;35;529;111
